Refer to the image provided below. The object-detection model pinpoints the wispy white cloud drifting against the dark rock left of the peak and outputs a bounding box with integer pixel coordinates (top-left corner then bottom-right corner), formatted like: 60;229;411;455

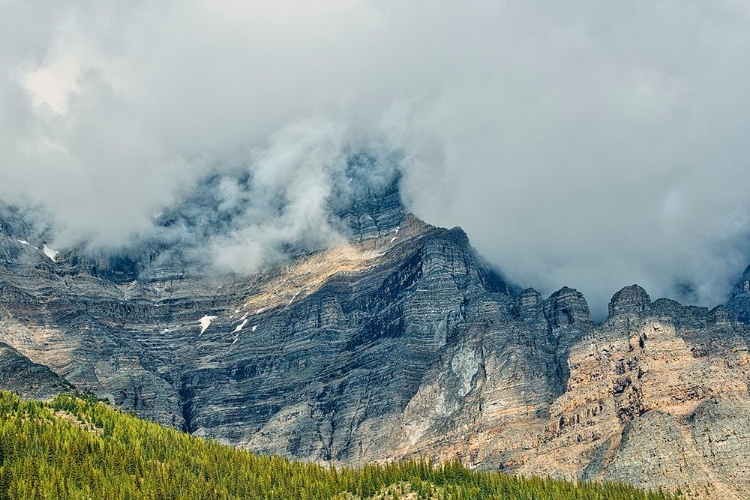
203;120;346;272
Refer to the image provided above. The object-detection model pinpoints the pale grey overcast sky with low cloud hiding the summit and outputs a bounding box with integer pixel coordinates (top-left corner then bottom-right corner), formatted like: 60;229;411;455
0;0;750;313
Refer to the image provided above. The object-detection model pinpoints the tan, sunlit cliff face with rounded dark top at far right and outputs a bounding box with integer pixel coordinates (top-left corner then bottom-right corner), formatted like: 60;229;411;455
516;292;750;498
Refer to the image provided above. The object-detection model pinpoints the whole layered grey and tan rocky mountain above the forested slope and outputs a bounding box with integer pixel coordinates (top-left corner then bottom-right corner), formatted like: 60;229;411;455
0;185;750;499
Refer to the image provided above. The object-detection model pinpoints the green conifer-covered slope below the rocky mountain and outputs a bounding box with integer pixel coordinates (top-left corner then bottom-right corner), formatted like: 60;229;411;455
0;391;671;500
